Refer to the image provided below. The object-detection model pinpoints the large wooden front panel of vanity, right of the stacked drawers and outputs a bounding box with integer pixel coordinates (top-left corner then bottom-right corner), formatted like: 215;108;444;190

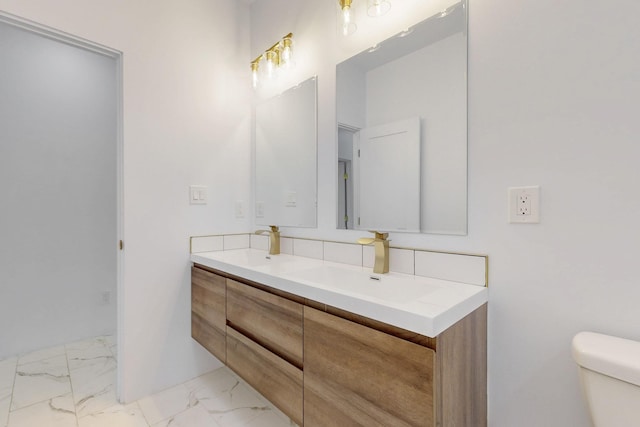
304;307;435;427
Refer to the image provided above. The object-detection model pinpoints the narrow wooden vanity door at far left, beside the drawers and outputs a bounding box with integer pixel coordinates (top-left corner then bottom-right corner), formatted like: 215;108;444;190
191;266;226;362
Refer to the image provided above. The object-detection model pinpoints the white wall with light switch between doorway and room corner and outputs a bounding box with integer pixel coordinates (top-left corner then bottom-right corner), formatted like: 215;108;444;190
0;0;251;401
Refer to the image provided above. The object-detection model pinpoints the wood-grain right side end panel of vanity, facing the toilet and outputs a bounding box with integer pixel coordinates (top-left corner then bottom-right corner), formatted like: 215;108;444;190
435;304;487;427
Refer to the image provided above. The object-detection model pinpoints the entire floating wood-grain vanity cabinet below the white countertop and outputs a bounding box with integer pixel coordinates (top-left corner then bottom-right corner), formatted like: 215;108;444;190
192;265;487;427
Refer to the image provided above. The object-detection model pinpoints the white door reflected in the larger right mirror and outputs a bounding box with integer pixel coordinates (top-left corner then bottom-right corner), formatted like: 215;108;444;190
353;117;420;232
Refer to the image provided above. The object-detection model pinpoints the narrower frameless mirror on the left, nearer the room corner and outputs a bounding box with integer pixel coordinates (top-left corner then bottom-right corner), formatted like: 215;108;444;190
254;77;317;227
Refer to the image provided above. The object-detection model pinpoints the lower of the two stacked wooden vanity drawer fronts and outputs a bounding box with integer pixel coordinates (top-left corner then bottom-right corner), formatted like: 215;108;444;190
227;327;303;426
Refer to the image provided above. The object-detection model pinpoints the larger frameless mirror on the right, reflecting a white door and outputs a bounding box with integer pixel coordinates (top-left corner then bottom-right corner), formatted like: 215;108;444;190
336;1;467;235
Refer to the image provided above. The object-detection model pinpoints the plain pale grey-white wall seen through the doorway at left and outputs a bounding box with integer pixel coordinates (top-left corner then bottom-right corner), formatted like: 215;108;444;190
0;22;118;359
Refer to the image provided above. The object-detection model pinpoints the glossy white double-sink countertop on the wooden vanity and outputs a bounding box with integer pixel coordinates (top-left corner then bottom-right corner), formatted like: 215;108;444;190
191;249;488;337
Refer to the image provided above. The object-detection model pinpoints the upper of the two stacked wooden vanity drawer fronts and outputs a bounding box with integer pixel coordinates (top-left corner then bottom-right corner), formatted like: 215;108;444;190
227;279;303;368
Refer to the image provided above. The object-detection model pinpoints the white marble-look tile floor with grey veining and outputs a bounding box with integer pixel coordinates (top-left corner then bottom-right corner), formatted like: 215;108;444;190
0;336;295;427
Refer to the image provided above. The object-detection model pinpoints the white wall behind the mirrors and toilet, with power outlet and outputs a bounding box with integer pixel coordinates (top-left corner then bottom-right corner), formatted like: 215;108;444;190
251;0;640;427
